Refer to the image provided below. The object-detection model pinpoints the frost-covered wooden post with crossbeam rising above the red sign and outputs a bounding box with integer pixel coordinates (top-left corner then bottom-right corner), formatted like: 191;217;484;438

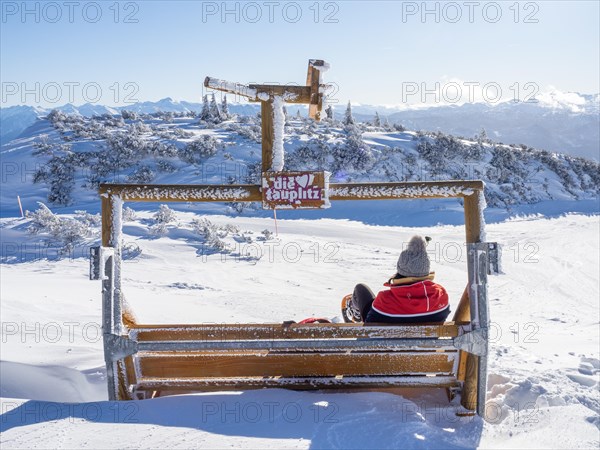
204;59;329;172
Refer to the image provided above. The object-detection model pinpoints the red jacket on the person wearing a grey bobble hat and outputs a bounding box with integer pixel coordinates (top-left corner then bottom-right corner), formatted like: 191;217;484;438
371;280;448;317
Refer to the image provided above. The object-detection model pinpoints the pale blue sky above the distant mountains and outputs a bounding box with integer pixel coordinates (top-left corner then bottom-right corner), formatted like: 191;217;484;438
0;0;600;107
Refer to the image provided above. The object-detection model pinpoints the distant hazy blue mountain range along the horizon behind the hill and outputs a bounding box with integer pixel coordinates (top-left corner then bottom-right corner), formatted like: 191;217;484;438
0;91;600;160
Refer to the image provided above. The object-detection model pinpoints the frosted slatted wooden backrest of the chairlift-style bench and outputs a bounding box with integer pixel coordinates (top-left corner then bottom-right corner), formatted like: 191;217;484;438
110;322;478;408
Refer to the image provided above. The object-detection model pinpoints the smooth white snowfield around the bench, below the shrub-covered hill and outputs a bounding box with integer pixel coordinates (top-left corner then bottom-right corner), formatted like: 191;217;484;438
0;211;600;448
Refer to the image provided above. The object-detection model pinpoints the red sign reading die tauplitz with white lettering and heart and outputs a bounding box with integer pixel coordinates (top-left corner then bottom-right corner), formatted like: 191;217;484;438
262;172;331;209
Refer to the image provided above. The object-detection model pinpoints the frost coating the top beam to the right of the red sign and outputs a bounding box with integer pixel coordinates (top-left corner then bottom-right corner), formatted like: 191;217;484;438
329;185;473;199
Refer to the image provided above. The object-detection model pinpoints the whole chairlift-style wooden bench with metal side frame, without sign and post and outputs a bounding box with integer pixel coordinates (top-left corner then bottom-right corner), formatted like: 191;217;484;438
97;180;497;415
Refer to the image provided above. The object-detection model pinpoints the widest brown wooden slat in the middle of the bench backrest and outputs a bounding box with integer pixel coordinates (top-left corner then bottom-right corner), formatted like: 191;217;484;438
138;352;456;378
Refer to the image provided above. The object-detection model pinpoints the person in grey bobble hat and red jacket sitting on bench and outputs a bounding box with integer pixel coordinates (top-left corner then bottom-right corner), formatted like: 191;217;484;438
351;236;450;323
